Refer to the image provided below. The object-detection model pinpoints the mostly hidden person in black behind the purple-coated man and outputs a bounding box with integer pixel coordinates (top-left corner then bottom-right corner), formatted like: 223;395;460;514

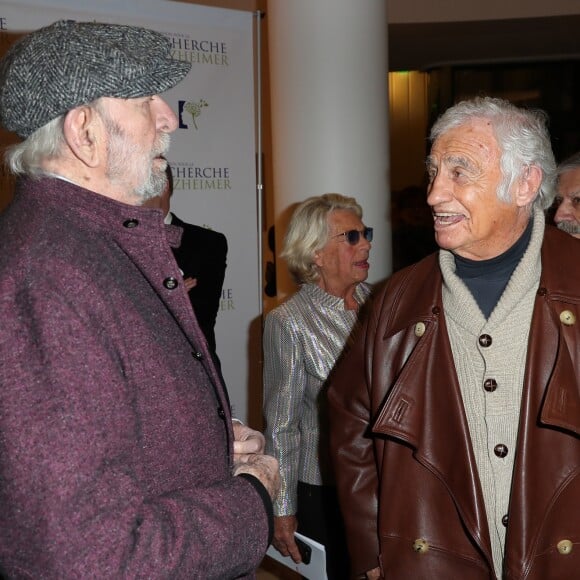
146;164;228;361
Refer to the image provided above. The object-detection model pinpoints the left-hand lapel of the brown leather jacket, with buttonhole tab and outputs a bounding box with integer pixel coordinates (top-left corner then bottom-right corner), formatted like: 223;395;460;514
373;260;492;562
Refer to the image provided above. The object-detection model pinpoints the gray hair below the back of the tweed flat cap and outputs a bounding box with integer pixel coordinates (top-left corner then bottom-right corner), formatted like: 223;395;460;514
5;115;65;177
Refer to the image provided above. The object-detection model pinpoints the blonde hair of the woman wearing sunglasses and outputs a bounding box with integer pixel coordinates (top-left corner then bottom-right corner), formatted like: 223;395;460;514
280;193;362;284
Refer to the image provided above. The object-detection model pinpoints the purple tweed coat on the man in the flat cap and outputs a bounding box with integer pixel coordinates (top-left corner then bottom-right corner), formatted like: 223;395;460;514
0;178;271;580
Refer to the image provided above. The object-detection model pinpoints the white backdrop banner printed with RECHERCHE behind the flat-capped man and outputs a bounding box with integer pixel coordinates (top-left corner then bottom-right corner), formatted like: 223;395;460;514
0;0;260;420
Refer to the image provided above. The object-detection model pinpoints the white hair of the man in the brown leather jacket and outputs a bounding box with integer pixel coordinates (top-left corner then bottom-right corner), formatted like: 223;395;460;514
430;97;556;209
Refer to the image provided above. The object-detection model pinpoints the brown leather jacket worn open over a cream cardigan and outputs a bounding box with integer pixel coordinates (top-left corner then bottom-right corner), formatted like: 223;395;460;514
329;227;580;580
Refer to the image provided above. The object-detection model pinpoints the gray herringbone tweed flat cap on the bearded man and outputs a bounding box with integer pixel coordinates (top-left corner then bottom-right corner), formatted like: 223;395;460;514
0;20;191;137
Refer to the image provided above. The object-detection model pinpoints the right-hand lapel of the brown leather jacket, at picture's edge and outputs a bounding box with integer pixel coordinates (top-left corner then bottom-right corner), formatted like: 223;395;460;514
505;268;580;578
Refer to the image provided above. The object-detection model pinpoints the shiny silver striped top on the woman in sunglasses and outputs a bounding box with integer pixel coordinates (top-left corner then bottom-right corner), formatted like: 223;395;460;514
263;284;370;516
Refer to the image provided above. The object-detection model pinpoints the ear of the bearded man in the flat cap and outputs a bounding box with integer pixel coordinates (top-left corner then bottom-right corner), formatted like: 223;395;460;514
63;105;103;167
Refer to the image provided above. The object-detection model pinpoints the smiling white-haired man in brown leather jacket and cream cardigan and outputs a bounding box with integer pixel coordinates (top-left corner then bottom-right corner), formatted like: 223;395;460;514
328;98;580;580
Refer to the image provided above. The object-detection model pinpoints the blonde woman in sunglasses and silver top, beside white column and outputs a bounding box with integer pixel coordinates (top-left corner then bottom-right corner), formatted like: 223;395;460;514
264;193;373;580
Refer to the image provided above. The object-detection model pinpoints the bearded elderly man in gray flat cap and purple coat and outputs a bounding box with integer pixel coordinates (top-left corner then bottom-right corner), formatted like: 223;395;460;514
0;21;278;580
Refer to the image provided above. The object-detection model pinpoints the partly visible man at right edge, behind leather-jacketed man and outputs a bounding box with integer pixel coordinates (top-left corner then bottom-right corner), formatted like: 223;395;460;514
554;152;580;238
